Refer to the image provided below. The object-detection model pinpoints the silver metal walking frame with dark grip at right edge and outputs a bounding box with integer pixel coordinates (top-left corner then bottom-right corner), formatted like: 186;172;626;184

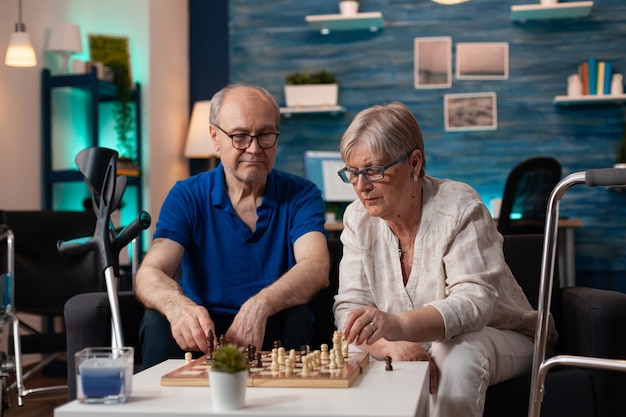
528;168;626;417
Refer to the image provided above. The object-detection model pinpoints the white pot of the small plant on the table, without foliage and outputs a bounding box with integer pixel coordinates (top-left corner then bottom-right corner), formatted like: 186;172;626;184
209;369;248;412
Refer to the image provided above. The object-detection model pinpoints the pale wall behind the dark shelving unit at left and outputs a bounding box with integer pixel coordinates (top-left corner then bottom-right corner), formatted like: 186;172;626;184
0;0;189;360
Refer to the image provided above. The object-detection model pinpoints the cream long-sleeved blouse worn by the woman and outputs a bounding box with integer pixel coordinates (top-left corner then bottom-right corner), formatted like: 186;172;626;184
334;176;556;339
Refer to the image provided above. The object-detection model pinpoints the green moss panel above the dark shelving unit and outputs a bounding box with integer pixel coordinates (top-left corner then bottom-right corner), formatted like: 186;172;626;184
89;34;134;89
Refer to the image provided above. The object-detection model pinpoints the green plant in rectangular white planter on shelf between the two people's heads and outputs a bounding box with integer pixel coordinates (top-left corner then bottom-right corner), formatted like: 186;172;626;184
285;70;339;107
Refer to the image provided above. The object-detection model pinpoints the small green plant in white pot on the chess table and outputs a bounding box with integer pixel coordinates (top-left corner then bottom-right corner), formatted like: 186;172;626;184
209;343;248;412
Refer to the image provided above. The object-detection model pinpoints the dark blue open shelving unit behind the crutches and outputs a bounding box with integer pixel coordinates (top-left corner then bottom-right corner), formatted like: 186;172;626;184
41;68;143;210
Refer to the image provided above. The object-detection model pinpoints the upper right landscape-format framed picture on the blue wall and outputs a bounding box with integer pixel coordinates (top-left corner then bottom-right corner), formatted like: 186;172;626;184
456;42;509;80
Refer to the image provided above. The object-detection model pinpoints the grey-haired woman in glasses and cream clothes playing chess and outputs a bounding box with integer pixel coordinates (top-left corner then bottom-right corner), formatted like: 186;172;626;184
334;103;552;417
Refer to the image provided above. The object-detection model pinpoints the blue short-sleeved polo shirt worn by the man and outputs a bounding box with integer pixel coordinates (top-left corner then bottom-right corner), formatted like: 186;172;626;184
154;164;326;314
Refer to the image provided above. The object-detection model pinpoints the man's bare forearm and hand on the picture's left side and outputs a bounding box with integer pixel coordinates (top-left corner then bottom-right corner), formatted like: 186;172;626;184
135;238;215;352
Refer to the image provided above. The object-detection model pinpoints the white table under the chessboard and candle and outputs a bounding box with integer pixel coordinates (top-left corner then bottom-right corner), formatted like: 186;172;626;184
54;359;429;417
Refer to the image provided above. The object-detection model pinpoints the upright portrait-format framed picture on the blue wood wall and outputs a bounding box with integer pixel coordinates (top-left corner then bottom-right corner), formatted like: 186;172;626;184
414;36;452;88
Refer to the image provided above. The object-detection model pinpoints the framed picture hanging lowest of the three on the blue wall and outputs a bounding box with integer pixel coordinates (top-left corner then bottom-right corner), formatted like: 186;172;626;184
443;92;498;131
